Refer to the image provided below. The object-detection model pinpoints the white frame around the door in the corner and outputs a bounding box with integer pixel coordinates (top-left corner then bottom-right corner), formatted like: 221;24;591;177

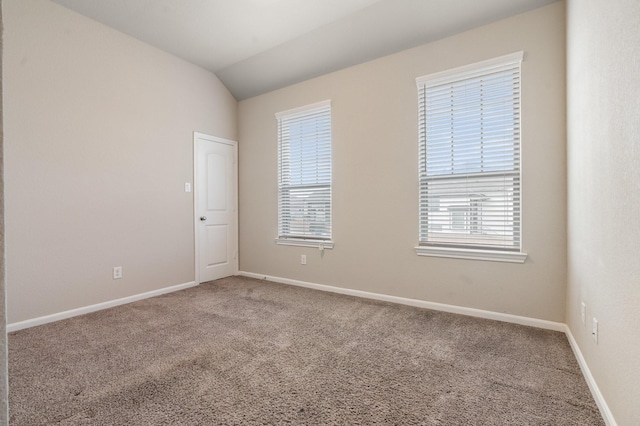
192;132;240;285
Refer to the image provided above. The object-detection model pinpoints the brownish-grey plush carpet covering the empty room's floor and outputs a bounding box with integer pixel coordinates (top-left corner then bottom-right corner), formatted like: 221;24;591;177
9;277;604;425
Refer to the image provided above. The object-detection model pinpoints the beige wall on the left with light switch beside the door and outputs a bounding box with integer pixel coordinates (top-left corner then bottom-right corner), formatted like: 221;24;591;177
4;0;237;323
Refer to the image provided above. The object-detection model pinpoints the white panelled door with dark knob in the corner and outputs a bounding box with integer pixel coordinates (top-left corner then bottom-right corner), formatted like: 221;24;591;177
193;133;238;284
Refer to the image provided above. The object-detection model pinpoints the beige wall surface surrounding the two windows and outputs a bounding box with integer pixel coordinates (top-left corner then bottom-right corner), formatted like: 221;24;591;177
238;3;566;322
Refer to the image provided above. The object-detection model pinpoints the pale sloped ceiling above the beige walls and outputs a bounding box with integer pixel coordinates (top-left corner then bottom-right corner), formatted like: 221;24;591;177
53;0;557;100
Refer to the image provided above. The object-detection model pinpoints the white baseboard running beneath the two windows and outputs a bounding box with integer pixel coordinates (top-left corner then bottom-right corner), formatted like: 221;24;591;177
238;271;566;332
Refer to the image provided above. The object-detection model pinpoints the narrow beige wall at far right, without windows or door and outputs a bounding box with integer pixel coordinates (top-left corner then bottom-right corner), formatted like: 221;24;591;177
566;0;640;425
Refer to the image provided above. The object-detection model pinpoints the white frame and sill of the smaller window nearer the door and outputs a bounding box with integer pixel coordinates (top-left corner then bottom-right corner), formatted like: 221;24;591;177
275;100;334;250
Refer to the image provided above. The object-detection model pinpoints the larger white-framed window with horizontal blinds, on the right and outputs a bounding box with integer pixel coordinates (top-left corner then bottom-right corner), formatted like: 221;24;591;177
416;52;526;262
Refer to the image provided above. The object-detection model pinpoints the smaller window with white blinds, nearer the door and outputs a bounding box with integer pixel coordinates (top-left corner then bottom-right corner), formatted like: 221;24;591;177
276;101;333;249
